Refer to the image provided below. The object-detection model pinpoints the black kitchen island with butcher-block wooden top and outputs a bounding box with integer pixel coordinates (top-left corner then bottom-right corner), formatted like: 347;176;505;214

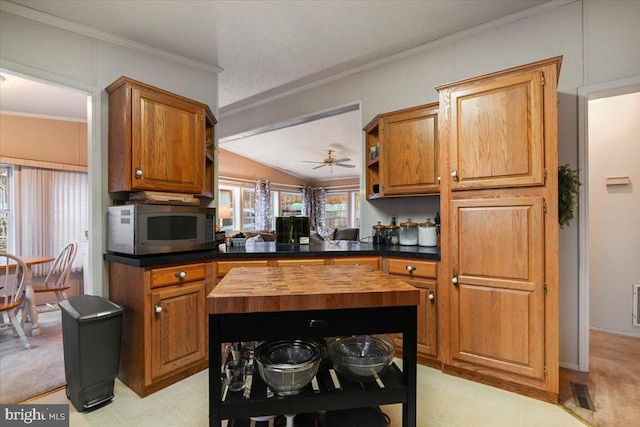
206;265;419;427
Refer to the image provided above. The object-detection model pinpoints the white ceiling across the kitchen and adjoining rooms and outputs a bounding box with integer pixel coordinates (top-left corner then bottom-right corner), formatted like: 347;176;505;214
0;0;548;180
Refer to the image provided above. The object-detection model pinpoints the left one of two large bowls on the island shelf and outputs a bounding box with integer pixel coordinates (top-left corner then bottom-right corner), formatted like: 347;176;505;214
254;340;322;396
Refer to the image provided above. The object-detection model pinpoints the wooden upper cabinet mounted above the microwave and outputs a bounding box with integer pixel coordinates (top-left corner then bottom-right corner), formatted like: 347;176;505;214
106;77;215;200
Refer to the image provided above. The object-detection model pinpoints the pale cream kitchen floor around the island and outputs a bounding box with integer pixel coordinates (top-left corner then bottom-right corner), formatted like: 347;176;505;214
29;365;585;427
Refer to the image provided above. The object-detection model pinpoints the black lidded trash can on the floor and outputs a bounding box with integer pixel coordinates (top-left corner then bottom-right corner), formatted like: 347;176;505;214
60;295;124;412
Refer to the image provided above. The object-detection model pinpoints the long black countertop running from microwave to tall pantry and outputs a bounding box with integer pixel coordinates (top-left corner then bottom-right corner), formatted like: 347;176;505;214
104;241;440;267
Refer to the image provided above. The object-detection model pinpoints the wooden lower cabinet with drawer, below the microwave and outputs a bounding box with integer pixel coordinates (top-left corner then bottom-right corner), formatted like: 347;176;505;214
109;262;213;397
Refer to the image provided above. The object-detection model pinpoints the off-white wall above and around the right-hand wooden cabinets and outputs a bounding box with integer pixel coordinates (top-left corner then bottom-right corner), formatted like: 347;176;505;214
218;1;640;368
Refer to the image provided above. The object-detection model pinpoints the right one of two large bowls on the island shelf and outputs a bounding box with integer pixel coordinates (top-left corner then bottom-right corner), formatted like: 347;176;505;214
327;335;396;382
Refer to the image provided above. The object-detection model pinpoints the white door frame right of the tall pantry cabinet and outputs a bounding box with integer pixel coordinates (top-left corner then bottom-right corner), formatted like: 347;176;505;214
578;76;640;372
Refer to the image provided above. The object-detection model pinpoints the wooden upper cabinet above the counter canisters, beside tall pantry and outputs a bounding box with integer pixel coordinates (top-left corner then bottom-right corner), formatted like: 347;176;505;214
364;103;439;199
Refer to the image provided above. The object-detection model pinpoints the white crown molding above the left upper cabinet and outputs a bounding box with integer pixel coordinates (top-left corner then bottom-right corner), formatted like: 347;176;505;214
0;0;223;74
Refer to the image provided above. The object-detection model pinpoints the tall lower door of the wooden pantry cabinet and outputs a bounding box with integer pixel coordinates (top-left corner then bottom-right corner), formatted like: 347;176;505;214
450;196;545;384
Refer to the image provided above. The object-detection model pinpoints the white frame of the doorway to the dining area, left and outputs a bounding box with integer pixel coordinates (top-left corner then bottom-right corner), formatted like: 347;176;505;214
1;58;108;297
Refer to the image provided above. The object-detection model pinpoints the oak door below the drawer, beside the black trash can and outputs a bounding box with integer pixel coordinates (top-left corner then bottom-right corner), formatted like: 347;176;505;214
147;281;206;383
